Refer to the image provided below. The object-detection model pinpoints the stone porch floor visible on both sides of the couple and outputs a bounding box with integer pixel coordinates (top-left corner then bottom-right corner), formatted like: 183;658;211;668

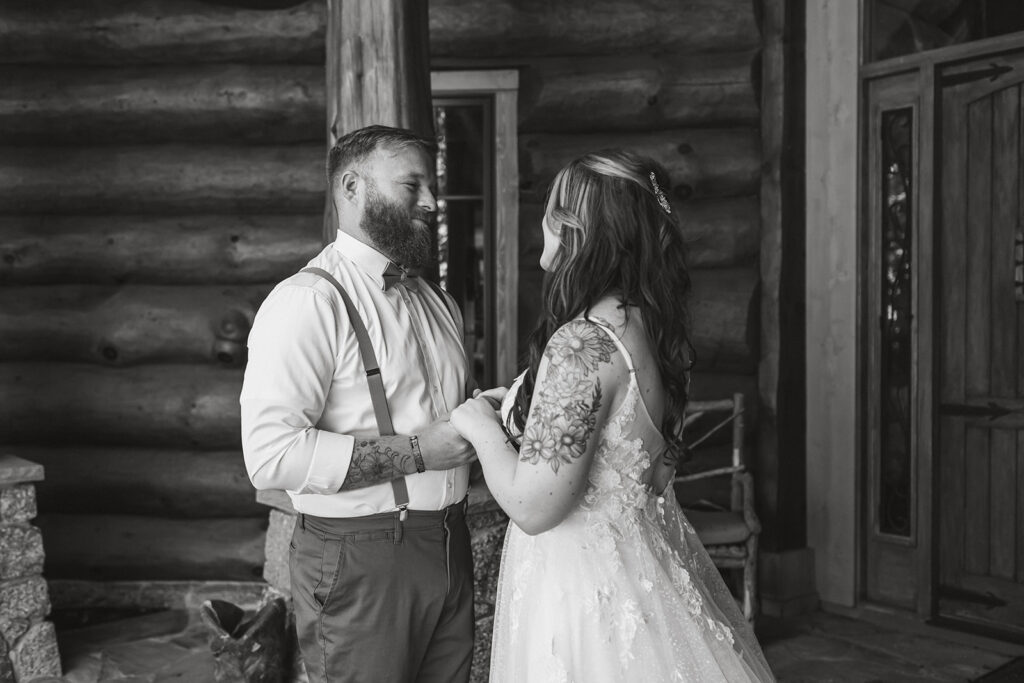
39;610;1024;683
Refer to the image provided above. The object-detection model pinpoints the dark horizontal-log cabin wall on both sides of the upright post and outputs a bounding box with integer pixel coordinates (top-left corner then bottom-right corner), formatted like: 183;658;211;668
0;0;762;581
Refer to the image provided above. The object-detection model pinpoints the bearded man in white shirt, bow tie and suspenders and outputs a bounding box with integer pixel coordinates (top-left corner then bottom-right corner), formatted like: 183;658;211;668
241;126;474;683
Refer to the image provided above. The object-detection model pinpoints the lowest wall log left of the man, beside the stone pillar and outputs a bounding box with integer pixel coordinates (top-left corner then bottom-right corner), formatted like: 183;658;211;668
35;514;266;581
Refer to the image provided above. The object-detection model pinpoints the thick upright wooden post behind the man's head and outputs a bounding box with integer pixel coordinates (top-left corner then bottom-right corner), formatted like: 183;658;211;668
324;0;434;243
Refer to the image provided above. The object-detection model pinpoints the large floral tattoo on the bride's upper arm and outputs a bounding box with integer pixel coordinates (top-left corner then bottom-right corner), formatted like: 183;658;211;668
519;321;615;474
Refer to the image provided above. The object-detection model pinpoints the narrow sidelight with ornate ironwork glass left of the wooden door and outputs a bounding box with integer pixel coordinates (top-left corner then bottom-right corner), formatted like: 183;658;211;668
862;71;930;611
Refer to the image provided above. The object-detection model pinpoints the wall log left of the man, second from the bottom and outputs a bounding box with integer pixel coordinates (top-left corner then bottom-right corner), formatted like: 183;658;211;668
13;446;260;518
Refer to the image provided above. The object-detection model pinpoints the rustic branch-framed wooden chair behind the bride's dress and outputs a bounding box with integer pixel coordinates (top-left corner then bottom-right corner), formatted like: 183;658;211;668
675;393;761;622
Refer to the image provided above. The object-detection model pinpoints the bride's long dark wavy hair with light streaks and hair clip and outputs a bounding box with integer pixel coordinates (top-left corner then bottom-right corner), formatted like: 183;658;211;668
510;150;694;456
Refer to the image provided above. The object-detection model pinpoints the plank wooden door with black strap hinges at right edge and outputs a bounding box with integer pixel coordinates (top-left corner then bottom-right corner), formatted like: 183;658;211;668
933;41;1024;639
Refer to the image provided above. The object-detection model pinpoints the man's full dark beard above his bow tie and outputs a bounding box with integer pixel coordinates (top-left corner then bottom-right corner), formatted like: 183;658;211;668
360;185;431;268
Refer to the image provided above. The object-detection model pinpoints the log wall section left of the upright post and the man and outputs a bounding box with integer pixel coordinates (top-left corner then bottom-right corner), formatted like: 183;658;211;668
0;0;325;589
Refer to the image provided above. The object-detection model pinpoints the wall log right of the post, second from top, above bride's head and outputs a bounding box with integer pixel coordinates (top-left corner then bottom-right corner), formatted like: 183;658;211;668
518;52;760;133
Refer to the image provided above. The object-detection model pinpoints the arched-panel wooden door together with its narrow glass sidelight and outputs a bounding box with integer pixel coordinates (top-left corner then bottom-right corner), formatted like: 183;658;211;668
861;34;1024;641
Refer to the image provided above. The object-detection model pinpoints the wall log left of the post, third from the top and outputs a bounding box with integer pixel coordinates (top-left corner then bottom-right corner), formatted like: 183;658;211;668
0;144;326;214
